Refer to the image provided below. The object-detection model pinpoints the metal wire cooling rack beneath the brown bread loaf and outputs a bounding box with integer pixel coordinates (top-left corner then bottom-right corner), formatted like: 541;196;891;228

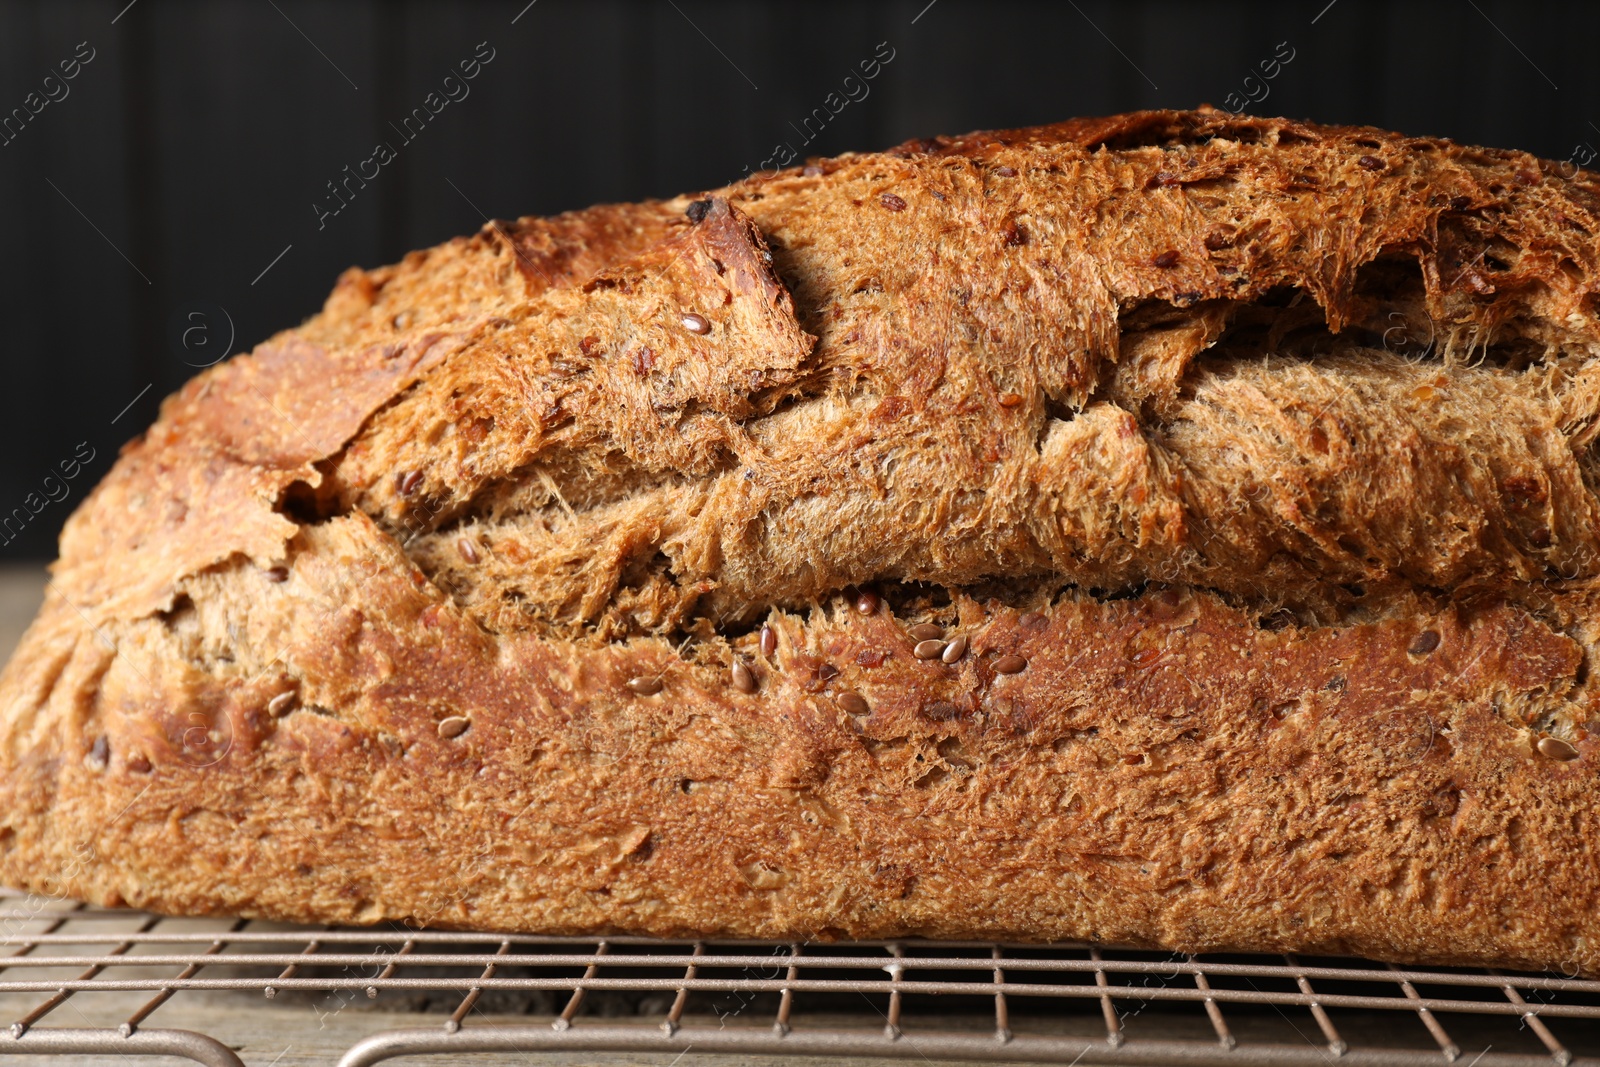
0;891;1600;1067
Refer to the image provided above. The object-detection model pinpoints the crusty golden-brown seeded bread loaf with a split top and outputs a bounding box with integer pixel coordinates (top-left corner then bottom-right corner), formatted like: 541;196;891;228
0;110;1600;973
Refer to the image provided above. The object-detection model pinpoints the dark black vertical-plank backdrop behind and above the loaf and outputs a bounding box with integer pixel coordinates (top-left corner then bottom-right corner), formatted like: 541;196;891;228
0;0;1600;558
